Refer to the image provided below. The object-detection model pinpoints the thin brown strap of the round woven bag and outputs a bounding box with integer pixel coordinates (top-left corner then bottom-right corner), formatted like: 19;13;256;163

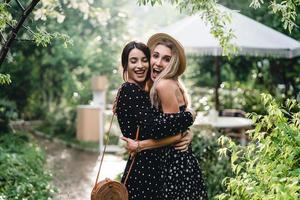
95;85;140;186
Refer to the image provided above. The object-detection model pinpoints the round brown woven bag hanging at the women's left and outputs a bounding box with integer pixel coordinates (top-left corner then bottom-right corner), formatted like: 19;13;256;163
91;179;128;200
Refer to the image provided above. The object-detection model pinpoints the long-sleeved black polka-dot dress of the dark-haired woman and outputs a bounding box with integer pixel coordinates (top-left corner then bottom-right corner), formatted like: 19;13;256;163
116;82;193;200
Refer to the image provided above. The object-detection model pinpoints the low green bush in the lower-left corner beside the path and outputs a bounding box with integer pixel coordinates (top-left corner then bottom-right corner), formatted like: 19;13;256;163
0;133;54;199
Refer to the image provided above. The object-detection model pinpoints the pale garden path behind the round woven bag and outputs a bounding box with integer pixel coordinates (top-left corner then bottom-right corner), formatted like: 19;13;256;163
37;135;126;200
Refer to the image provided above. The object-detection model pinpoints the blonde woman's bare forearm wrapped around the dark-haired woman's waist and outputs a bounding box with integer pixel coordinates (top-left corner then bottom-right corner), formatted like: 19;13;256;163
139;133;181;150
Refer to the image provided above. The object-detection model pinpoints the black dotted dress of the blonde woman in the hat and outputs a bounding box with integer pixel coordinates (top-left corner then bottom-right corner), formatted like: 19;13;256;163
160;106;208;200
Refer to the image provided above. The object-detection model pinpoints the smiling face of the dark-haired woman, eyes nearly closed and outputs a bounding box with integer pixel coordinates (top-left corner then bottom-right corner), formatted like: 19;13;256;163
127;48;149;84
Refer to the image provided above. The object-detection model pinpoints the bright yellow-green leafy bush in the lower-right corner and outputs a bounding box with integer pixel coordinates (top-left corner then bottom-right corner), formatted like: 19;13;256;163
217;95;300;200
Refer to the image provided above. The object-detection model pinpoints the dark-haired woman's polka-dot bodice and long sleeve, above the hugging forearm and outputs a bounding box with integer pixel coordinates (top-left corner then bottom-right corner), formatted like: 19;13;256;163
116;83;194;139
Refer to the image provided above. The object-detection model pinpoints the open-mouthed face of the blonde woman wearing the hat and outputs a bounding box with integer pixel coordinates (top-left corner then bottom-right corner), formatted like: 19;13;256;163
150;44;172;81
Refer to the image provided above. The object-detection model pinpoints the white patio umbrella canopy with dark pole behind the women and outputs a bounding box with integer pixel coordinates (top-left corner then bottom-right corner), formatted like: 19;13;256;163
158;6;300;109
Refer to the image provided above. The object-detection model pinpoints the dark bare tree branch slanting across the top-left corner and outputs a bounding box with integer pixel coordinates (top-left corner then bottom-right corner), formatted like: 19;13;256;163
0;0;40;66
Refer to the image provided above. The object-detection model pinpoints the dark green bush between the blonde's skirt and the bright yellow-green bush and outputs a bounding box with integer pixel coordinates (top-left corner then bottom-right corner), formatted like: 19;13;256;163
192;129;232;199
